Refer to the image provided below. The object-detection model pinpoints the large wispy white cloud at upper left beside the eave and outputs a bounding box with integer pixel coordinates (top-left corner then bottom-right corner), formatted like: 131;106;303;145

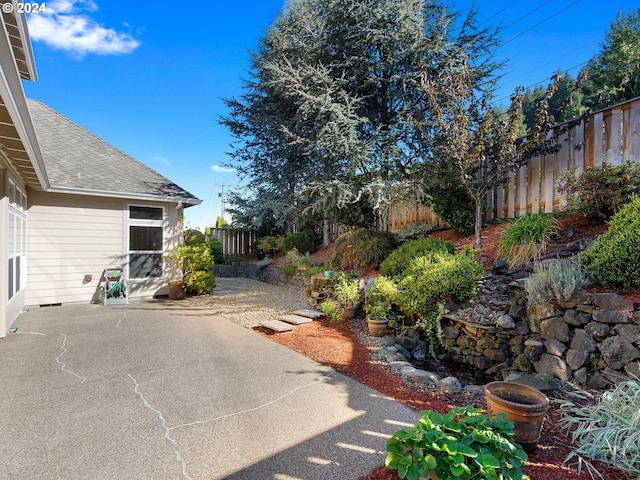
27;0;140;57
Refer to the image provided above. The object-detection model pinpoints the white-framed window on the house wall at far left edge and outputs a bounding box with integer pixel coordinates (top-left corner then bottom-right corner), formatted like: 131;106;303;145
7;178;27;300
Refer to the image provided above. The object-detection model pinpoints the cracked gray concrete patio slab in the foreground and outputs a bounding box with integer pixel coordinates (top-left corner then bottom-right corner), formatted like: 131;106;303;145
0;300;418;480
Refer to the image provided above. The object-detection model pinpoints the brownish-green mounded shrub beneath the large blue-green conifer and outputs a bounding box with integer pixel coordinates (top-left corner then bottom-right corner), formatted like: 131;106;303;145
327;228;397;270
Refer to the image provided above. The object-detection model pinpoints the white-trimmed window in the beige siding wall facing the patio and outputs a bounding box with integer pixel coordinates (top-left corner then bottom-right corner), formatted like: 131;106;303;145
127;205;166;279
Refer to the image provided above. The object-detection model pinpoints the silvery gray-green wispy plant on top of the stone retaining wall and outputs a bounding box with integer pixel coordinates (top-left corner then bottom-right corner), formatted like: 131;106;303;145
525;261;587;306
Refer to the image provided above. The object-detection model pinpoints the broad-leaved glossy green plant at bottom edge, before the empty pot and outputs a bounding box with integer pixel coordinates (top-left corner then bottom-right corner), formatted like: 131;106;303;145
385;406;527;480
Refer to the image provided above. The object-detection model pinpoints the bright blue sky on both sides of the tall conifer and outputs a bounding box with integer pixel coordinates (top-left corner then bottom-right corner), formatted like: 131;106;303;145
25;0;639;230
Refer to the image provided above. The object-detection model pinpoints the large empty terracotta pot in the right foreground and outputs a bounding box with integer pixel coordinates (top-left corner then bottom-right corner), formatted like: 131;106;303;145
484;382;549;453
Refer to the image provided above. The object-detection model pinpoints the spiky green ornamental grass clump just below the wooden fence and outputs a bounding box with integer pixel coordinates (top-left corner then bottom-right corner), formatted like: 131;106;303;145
496;213;559;267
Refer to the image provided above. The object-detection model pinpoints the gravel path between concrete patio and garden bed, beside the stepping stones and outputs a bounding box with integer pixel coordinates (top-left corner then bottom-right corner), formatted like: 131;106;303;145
189;277;309;328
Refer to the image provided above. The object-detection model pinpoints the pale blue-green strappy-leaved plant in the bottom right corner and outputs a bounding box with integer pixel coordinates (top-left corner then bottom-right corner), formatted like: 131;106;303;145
560;377;640;478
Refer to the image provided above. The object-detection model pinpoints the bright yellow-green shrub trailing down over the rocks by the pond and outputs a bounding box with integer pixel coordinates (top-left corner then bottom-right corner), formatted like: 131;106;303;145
396;253;484;356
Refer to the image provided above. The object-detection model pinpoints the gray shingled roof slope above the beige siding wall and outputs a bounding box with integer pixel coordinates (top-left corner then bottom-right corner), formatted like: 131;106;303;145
27;99;201;206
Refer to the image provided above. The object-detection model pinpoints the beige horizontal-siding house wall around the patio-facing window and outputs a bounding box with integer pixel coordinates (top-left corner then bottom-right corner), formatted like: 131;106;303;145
26;191;181;305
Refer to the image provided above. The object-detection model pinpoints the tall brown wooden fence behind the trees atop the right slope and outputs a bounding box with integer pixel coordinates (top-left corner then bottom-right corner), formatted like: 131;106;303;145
389;97;640;230
